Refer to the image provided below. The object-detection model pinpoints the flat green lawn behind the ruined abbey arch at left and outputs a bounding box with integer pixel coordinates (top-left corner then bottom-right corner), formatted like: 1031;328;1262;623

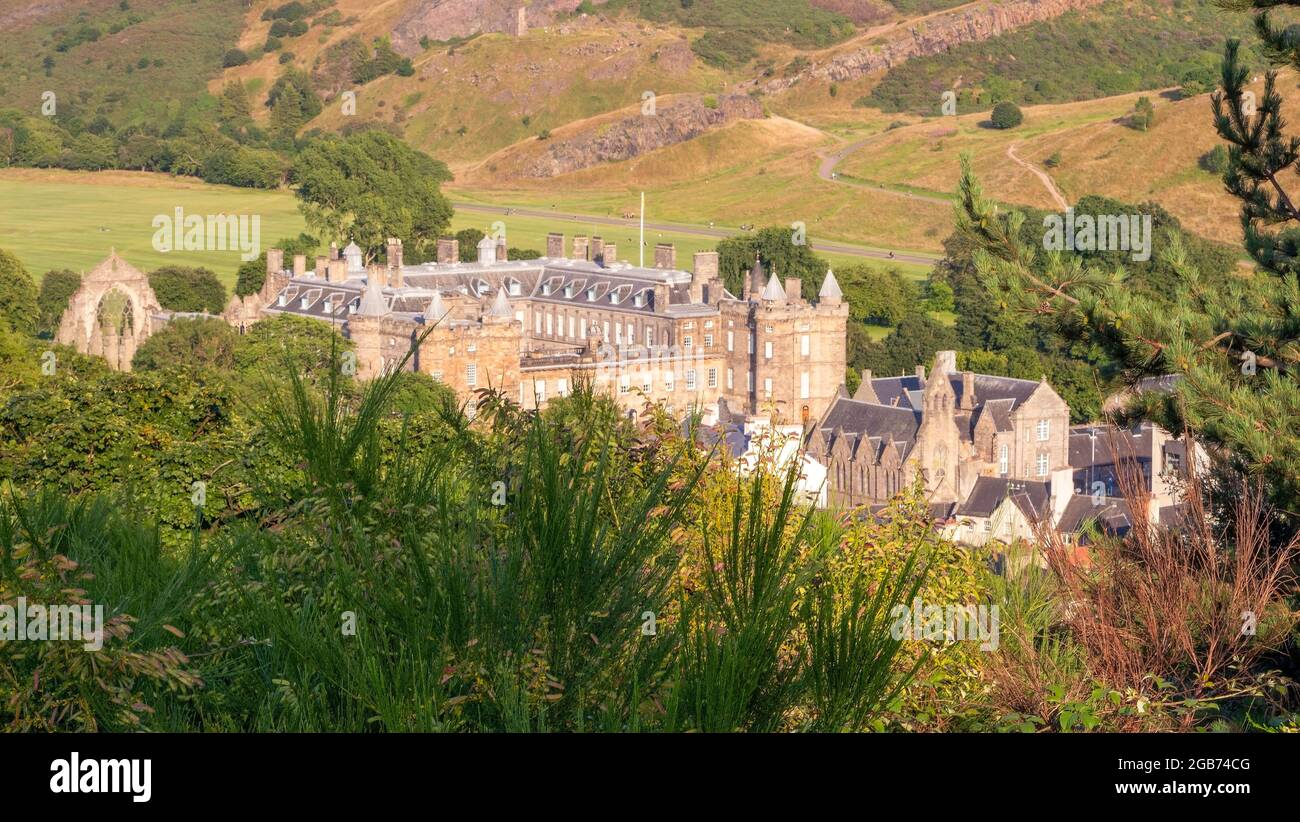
0;169;304;287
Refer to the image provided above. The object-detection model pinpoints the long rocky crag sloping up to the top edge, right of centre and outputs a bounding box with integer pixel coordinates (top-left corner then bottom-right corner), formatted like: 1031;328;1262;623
763;0;1104;94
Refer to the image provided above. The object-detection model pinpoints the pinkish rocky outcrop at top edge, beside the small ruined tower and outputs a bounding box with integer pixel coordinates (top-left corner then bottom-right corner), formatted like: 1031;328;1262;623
393;0;605;57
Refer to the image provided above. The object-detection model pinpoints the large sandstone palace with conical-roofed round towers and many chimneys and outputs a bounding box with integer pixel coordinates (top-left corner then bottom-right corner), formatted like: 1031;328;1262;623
226;233;849;424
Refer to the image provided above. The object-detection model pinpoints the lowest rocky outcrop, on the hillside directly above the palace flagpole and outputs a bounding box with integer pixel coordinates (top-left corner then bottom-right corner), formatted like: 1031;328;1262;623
524;94;763;177
